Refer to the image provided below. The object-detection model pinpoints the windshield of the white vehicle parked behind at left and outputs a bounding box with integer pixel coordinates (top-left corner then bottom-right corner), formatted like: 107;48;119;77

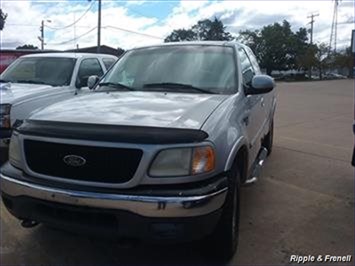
1;57;76;86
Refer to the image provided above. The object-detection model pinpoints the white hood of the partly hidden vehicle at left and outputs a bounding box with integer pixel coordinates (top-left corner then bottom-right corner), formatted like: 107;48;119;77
0;83;58;104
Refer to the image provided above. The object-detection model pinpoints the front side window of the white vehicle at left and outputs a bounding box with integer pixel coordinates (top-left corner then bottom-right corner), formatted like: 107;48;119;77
76;58;104;87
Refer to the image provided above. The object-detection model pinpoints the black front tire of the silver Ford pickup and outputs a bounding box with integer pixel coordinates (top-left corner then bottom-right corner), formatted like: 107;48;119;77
207;164;240;260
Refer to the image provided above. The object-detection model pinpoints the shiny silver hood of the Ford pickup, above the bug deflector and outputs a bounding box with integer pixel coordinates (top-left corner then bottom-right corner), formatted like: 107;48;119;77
30;91;228;129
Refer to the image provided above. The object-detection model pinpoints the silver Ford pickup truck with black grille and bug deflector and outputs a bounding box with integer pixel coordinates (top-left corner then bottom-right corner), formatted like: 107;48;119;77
1;42;276;258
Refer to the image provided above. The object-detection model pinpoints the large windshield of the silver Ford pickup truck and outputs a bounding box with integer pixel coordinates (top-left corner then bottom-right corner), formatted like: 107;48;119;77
100;45;236;94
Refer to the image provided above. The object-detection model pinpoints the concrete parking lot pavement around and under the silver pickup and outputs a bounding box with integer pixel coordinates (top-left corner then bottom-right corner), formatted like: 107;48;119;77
0;80;355;265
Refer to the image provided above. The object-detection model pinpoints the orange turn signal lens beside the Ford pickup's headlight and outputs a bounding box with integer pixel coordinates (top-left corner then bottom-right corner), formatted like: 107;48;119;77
191;146;215;175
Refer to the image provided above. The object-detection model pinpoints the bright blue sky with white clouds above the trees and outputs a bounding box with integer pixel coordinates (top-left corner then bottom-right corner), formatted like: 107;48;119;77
0;0;354;50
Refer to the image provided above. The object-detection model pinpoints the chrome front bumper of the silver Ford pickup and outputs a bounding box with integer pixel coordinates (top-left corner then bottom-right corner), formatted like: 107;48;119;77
0;174;228;217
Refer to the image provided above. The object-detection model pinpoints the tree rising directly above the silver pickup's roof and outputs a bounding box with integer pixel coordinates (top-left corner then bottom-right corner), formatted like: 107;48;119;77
165;18;234;42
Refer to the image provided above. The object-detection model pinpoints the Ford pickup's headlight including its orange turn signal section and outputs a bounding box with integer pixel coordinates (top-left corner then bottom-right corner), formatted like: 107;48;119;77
149;146;215;177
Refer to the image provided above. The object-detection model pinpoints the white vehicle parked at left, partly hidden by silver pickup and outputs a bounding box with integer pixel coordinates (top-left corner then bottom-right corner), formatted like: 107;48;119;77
0;53;117;161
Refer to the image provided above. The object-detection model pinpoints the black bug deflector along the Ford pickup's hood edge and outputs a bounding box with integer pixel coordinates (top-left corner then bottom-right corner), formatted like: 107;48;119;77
16;120;208;144
